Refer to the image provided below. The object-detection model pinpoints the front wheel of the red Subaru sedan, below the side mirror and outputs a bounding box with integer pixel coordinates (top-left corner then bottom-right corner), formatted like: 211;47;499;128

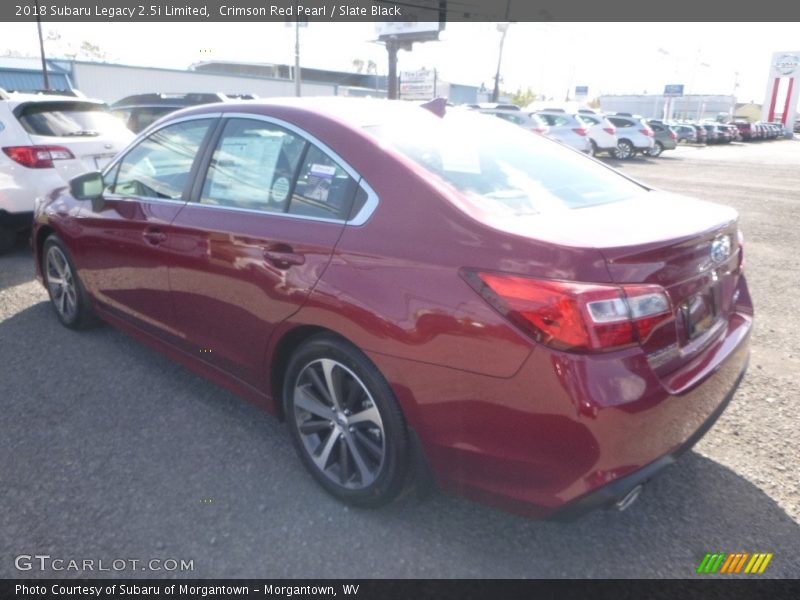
42;234;95;329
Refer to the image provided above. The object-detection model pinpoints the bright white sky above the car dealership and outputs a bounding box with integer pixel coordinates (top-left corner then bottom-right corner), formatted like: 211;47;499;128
0;22;800;103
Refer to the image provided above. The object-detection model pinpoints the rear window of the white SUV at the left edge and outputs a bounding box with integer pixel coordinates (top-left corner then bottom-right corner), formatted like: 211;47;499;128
17;102;130;137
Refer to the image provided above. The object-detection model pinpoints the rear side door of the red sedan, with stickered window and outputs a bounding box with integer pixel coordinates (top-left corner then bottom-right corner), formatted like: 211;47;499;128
169;116;358;386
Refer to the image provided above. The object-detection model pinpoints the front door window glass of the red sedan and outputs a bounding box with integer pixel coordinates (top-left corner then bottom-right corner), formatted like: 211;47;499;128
110;119;213;200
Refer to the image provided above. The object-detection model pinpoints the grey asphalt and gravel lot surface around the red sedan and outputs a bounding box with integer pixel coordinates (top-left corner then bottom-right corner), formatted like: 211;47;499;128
0;141;800;577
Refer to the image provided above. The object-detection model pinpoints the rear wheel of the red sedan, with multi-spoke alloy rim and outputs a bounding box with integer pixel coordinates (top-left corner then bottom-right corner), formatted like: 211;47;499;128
283;335;409;508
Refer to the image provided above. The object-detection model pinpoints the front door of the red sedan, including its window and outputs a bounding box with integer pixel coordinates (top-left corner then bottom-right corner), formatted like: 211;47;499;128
75;115;218;338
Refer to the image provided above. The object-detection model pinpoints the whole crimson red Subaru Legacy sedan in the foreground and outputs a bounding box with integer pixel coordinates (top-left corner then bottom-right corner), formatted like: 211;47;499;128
33;98;753;517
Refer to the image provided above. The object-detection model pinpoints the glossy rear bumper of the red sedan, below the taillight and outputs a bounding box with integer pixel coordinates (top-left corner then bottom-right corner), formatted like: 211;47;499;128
371;284;752;518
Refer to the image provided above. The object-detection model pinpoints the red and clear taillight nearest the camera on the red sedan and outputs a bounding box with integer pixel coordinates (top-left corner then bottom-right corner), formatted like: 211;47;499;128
463;270;674;352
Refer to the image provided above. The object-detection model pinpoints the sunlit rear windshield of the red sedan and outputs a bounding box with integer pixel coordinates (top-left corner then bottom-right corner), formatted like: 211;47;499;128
366;110;645;215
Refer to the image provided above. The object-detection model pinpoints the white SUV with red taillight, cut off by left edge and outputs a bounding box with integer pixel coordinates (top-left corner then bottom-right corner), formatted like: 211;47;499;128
0;89;134;253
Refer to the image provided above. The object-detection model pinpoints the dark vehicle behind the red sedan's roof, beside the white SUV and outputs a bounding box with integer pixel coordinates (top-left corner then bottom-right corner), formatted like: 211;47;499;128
111;93;257;133
